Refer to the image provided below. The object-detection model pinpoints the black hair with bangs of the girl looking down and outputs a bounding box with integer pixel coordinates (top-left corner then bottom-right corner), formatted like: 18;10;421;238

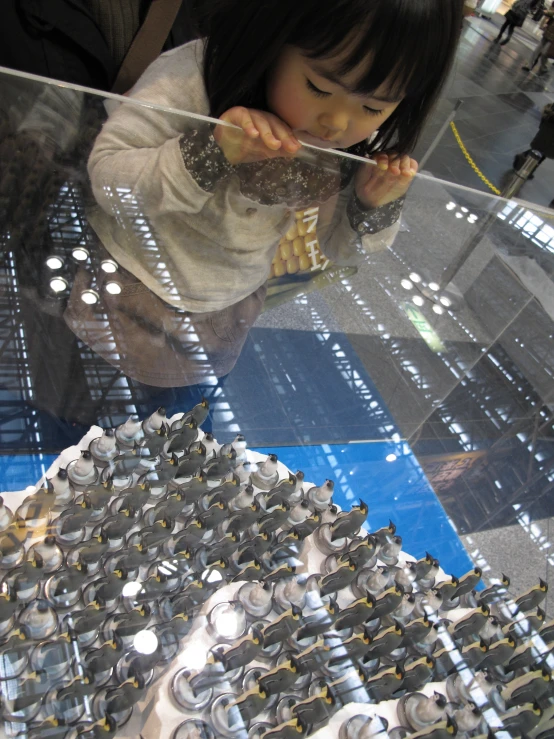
196;0;464;154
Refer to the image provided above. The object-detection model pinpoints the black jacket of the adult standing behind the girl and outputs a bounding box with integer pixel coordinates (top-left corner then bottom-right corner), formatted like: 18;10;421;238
0;0;195;90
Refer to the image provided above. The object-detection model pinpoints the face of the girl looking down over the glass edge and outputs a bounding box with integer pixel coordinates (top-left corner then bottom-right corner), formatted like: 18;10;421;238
267;46;401;149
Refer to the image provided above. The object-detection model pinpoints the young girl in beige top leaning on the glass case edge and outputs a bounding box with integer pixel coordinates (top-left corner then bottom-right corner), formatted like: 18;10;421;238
71;0;463;387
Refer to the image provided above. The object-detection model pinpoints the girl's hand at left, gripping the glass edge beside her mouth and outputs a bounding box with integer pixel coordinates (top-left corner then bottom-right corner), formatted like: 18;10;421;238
214;107;301;164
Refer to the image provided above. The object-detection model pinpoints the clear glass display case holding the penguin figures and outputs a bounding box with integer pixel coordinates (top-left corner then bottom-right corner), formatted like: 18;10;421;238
0;65;554;739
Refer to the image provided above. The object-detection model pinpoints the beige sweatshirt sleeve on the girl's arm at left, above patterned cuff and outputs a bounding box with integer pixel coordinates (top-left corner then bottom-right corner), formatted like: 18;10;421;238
88;42;218;217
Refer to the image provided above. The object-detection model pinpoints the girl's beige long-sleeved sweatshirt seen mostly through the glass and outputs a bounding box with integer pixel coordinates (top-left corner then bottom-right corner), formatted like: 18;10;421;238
88;41;397;312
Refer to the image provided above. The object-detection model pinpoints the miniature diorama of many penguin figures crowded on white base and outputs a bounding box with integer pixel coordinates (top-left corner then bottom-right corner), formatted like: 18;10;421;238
0;400;554;739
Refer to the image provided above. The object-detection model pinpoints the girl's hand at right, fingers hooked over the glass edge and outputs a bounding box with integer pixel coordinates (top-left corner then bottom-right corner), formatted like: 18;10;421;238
354;153;417;208
